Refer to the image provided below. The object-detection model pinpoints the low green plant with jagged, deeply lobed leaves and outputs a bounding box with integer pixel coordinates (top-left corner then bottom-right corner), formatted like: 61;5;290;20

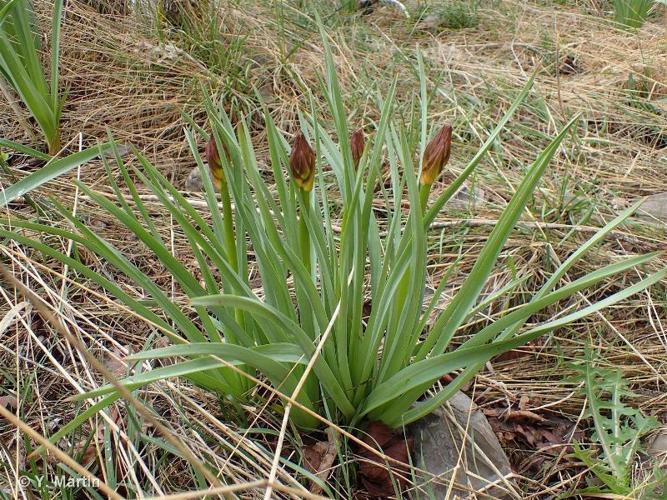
570;350;660;496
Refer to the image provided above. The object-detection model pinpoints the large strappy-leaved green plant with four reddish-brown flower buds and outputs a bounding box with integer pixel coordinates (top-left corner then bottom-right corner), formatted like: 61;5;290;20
6;45;667;441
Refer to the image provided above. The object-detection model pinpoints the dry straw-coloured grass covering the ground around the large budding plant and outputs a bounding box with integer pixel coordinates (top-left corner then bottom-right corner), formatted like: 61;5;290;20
0;0;667;498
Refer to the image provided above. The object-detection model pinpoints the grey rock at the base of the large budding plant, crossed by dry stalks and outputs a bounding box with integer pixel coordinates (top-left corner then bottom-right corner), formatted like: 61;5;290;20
408;392;519;499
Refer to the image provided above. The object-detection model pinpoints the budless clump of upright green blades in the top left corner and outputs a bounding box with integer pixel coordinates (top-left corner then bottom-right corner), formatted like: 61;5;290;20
0;0;64;155
